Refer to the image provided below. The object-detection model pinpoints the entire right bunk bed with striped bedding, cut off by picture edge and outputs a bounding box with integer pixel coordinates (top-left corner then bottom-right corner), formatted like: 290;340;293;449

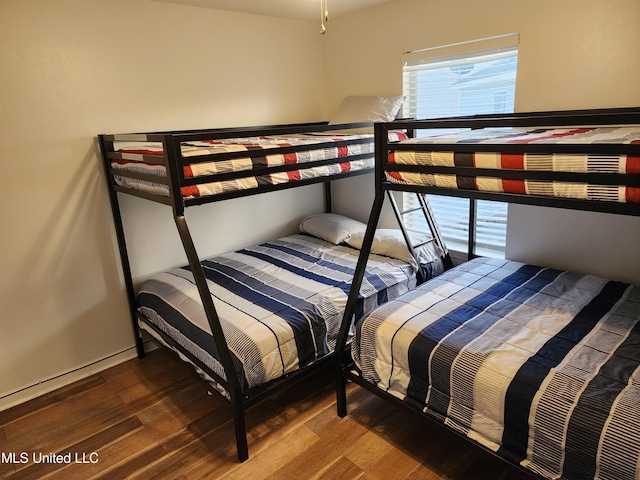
337;108;640;480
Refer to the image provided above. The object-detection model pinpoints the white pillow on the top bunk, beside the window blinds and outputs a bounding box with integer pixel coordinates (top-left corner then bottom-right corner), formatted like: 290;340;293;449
329;95;404;125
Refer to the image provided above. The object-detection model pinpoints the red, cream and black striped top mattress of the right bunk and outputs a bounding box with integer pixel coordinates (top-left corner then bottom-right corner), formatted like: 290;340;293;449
386;127;640;203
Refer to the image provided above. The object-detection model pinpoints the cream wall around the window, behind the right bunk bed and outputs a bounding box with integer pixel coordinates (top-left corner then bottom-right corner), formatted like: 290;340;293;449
325;0;640;284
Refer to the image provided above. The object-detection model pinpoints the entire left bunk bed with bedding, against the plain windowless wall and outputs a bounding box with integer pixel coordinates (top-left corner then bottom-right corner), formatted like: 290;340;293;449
99;122;442;461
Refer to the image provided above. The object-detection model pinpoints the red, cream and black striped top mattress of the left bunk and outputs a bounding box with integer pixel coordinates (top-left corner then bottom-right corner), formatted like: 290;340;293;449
111;132;406;198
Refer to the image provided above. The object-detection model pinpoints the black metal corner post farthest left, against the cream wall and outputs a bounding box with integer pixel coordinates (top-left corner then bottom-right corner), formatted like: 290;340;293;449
98;135;145;358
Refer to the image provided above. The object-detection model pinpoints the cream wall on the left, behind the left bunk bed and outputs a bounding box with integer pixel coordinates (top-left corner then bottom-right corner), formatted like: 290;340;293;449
0;0;326;410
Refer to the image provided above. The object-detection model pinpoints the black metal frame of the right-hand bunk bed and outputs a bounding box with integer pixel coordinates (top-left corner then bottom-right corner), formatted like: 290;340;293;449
336;107;640;478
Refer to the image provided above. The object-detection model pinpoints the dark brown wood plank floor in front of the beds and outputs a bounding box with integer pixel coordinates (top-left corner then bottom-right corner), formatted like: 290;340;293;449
0;351;528;480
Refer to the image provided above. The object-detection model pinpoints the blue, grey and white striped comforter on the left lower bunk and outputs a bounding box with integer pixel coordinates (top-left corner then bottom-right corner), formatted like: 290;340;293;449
138;235;415;387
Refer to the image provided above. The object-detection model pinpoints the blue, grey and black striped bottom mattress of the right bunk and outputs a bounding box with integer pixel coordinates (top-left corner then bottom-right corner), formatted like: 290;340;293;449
352;259;640;480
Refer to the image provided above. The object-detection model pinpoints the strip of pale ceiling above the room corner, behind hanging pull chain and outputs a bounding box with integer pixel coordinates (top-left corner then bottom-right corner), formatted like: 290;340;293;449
156;0;399;21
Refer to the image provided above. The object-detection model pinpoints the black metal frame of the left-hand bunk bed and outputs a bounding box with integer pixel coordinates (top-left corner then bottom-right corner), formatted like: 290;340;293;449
98;118;380;461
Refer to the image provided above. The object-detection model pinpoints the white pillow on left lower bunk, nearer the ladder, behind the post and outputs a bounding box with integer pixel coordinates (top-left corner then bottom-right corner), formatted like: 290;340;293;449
347;228;442;269
